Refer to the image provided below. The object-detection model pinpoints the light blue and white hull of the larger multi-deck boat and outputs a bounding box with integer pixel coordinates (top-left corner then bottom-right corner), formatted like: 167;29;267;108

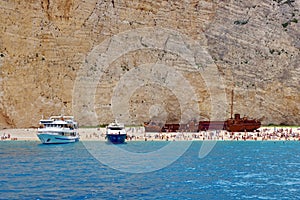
37;133;79;144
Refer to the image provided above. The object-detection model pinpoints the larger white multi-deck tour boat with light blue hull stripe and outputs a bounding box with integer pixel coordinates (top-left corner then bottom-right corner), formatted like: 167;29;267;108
37;116;79;144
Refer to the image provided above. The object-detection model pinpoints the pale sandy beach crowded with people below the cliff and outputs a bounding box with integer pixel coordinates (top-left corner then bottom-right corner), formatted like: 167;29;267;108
0;126;300;141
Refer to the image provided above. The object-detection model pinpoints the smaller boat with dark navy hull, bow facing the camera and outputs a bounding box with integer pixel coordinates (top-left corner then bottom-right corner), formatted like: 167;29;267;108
106;122;127;144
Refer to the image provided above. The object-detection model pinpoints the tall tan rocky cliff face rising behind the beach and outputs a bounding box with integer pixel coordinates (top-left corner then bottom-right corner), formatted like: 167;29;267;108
0;0;300;128
